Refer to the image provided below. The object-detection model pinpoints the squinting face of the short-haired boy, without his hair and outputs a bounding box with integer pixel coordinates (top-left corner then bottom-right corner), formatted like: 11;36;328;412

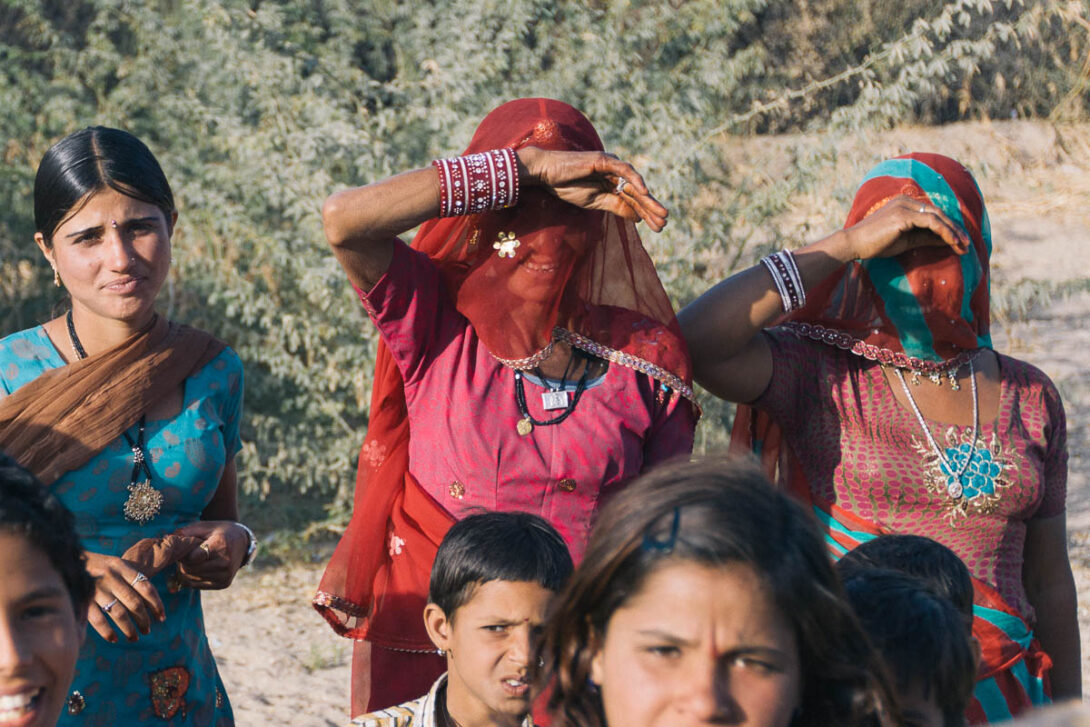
424;581;554;727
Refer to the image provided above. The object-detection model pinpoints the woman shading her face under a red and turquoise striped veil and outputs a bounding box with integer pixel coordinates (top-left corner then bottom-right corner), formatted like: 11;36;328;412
679;154;1082;724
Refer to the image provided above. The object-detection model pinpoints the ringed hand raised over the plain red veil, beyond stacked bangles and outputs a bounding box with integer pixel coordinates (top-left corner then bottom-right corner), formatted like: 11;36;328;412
518;146;669;232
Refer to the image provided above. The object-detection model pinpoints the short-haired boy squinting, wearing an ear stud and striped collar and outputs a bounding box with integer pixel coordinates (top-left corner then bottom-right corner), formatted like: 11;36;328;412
352;512;572;727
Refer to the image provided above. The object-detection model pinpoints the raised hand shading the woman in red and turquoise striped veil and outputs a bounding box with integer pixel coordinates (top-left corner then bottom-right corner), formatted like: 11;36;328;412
843;195;970;262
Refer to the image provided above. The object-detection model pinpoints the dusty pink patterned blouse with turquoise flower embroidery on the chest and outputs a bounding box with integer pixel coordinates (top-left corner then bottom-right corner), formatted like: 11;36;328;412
753;329;1067;626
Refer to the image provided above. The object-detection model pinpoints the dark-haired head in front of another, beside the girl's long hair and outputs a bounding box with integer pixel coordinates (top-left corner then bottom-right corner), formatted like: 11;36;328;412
844;568;977;727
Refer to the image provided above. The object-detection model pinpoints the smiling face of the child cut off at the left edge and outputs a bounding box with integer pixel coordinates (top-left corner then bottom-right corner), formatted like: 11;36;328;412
0;532;86;727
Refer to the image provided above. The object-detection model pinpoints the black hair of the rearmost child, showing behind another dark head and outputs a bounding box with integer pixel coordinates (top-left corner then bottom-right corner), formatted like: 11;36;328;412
836;535;972;623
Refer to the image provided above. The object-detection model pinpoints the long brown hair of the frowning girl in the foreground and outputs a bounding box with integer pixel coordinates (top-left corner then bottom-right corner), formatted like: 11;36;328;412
537;458;898;727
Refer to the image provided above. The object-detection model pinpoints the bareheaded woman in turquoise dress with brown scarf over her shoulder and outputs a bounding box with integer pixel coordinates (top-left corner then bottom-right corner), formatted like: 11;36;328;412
0;126;249;726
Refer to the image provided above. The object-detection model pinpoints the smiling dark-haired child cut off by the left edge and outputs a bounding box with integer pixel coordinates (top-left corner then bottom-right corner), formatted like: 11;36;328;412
0;453;95;727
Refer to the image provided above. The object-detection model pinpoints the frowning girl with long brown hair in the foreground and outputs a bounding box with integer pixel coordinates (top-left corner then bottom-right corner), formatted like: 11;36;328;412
540;460;898;727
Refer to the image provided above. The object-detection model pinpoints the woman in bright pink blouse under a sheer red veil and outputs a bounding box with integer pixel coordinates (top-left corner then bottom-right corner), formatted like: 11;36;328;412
315;98;697;716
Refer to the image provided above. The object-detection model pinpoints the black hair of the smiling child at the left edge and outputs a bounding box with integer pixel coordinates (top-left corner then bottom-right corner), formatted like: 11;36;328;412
0;452;95;614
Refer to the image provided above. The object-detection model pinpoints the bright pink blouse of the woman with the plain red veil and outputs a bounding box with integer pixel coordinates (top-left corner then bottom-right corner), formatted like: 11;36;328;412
360;245;695;562
